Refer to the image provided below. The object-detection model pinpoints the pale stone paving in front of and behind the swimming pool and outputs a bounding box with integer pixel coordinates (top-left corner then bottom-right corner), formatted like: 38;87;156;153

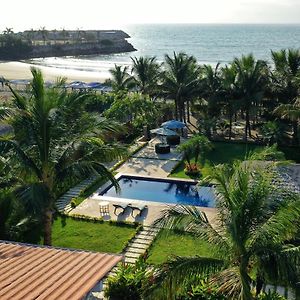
70;138;216;225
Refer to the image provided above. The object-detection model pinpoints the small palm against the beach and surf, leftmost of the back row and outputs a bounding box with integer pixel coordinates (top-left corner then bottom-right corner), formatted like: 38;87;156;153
109;65;134;92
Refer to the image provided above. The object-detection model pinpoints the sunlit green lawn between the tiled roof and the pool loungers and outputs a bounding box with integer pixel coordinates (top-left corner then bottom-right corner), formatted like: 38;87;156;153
52;217;136;253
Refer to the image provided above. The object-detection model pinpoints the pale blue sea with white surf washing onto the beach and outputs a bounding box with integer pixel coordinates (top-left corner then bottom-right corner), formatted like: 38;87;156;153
31;24;300;78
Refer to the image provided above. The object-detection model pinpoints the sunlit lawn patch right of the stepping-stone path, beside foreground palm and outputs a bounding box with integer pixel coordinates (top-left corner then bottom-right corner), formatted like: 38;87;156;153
147;232;213;264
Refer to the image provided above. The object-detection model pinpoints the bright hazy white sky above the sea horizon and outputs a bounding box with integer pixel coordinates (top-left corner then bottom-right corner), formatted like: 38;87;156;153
0;0;300;32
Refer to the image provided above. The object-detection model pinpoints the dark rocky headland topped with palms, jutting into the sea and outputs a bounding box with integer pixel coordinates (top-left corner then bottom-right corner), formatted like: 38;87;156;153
0;30;136;60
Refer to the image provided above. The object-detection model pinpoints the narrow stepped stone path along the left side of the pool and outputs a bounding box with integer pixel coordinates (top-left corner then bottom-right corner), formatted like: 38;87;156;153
56;176;97;213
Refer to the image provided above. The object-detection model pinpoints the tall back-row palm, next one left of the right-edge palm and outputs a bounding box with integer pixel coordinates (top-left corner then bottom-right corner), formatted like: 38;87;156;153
233;55;268;140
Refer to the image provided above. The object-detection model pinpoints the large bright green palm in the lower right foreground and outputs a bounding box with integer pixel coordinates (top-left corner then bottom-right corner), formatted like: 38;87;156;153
153;161;300;300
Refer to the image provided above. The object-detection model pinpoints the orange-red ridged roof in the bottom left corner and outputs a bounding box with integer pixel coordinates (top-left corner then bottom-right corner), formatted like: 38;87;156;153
0;241;122;300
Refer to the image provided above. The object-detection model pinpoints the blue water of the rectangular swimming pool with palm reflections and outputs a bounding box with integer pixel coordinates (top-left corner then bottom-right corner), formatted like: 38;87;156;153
101;176;215;207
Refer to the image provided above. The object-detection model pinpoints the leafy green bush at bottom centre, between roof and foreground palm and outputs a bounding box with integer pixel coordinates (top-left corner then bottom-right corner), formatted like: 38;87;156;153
104;260;153;300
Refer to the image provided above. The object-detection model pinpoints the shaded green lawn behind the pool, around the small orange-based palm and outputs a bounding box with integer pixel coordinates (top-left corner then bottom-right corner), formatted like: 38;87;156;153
170;142;263;178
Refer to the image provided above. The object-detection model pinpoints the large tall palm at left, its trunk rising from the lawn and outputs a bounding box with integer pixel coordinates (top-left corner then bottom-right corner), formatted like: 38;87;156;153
0;68;124;245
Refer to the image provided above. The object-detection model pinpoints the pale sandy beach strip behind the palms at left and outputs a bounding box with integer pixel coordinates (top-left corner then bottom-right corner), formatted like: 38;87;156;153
0;62;107;82
